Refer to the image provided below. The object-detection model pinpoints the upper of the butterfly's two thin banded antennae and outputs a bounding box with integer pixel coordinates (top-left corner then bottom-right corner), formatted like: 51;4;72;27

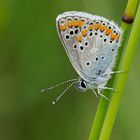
41;79;78;92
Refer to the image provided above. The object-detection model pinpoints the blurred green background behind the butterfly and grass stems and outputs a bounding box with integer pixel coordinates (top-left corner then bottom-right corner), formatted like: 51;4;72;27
0;0;140;140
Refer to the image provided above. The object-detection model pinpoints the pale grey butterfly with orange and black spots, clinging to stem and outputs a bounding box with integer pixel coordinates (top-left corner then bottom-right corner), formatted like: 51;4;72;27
42;11;123;104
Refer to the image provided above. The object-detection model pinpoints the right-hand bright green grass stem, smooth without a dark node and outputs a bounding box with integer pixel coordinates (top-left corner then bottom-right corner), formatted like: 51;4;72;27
100;5;140;140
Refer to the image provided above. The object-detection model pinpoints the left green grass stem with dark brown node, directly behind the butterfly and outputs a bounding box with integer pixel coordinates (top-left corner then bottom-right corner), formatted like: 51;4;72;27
89;0;138;140
